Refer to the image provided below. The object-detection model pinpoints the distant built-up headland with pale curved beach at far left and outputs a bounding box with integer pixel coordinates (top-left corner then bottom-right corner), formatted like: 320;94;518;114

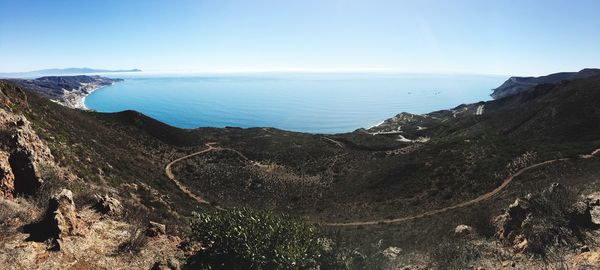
11;75;123;109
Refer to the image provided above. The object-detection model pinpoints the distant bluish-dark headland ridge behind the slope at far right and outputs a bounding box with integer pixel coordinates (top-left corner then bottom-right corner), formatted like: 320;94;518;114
491;68;600;99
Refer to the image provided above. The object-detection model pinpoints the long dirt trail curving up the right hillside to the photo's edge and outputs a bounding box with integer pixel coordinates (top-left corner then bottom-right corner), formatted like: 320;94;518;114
321;148;600;226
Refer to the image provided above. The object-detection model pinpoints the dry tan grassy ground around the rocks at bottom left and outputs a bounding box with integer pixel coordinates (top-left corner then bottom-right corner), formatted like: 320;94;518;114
0;208;180;270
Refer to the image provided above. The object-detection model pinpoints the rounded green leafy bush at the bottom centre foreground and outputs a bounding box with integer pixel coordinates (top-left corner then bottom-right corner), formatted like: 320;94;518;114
188;208;322;269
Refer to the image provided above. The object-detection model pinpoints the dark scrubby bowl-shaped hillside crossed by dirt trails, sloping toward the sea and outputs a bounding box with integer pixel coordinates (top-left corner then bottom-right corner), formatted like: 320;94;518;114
0;73;600;269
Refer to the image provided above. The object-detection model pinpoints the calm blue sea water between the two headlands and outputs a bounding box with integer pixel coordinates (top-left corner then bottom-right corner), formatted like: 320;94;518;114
85;74;506;133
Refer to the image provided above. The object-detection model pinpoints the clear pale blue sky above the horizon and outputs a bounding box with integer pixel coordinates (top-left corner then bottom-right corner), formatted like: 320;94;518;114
0;0;600;75
